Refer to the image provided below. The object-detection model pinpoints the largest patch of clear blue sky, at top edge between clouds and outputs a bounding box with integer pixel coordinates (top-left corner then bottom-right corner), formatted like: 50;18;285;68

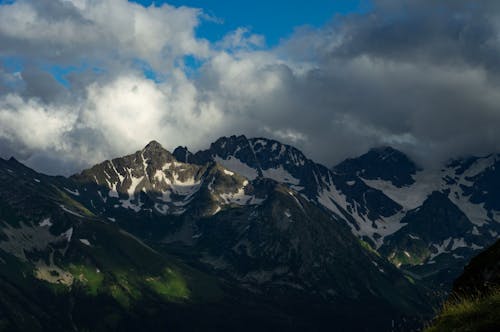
133;0;369;46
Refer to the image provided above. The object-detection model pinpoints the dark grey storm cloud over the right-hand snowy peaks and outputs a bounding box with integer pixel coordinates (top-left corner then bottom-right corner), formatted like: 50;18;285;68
250;1;500;166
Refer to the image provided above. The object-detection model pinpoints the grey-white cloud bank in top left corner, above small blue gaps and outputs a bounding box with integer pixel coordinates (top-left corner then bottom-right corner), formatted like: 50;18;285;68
0;0;209;71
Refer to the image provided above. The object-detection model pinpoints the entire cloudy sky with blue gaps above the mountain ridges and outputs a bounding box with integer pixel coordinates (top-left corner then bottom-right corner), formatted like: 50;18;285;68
0;0;500;175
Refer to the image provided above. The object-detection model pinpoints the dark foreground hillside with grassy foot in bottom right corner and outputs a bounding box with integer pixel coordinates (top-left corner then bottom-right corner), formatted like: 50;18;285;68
425;240;500;332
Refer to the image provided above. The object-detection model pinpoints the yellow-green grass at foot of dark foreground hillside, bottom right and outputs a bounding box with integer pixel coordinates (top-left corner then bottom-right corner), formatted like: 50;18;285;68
425;288;500;332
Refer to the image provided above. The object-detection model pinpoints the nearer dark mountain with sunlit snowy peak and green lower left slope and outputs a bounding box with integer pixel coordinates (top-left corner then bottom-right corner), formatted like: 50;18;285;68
0;142;430;331
